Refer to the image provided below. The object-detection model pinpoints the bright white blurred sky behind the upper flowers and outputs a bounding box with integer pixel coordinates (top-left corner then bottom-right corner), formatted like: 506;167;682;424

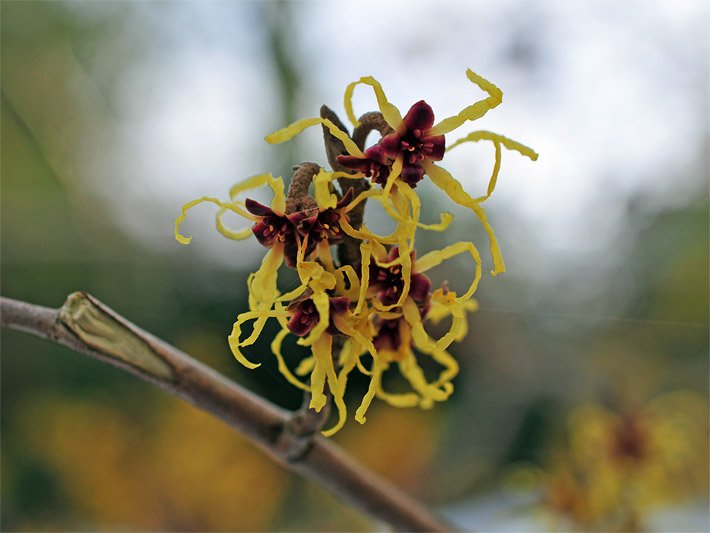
65;1;708;290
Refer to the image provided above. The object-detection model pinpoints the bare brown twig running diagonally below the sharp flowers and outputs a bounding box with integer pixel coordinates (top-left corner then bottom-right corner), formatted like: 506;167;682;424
0;292;450;531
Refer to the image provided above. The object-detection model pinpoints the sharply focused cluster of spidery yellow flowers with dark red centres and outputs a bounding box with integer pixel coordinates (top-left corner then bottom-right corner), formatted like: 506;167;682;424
175;70;537;435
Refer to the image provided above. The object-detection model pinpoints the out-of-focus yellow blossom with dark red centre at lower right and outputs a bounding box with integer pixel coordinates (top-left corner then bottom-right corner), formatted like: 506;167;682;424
540;391;708;531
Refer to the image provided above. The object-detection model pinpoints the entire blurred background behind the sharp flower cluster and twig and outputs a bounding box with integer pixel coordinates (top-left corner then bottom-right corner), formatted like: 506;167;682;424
0;1;710;531
